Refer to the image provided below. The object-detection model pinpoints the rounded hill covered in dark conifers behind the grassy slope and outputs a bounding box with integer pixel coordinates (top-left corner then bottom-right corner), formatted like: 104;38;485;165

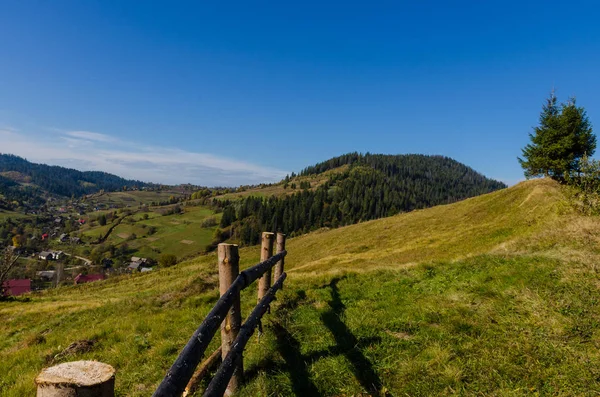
213;153;506;244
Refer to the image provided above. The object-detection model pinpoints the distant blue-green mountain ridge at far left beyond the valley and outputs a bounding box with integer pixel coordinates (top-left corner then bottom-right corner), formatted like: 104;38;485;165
0;153;148;209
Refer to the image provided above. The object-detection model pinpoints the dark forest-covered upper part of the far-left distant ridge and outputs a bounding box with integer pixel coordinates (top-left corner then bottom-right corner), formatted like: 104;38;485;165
0;153;146;196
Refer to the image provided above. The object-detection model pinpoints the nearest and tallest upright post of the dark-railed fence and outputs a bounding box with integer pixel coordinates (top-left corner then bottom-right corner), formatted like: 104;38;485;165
218;243;244;396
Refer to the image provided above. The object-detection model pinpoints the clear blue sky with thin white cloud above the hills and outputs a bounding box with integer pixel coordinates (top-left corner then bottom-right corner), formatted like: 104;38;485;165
0;0;600;185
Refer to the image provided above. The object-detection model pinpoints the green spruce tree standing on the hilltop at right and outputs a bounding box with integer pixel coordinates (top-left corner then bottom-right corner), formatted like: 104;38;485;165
518;92;596;179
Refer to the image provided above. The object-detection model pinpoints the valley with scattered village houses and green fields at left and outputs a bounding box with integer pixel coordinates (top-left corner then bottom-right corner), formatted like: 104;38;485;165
0;187;214;296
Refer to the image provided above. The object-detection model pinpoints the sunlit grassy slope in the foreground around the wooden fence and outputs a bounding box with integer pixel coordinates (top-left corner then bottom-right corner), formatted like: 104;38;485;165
0;181;600;396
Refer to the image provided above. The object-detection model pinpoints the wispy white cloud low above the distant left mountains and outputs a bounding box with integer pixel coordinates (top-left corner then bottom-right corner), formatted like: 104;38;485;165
0;127;287;186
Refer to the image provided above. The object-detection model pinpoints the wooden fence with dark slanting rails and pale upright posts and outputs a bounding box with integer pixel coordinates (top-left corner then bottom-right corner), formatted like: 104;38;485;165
153;233;287;397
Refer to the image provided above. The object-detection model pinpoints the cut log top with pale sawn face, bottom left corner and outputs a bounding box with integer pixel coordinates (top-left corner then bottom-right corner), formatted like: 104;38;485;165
35;361;115;397
